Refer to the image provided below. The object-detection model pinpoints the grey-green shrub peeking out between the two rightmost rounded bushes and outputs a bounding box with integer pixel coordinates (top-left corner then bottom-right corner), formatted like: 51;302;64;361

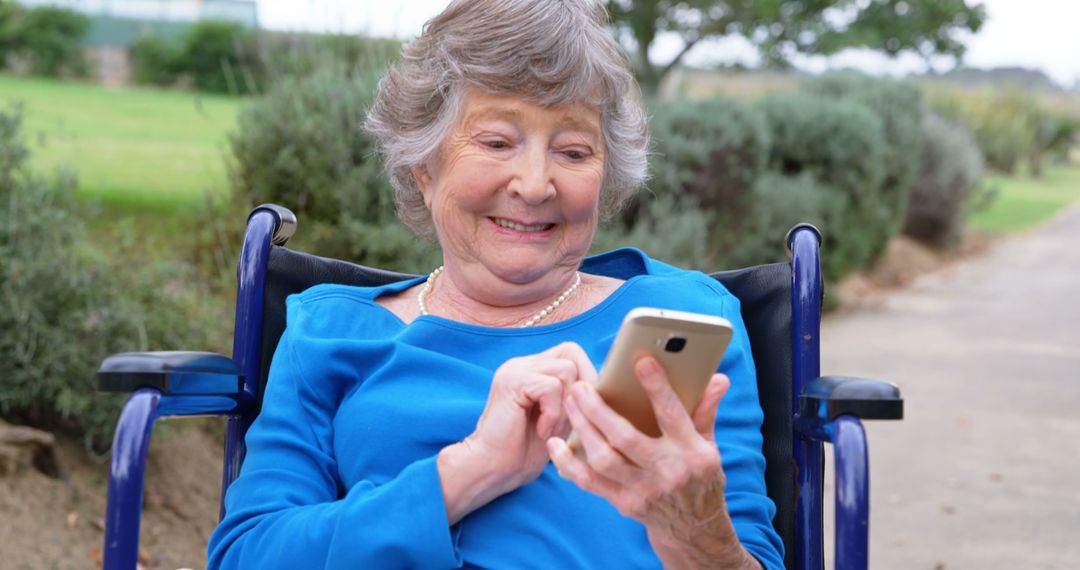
802;73;926;258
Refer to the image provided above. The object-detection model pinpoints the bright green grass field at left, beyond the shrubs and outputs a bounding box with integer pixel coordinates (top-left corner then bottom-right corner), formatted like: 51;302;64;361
0;74;242;211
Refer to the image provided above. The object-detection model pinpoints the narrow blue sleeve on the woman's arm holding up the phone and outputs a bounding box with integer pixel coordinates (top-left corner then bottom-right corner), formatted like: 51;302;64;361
716;295;784;570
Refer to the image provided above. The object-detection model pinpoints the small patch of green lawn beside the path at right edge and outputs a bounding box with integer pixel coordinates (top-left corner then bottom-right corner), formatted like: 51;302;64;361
970;164;1080;234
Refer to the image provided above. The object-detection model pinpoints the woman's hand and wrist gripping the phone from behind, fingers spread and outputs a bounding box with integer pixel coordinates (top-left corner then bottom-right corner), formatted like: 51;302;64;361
548;356;760;568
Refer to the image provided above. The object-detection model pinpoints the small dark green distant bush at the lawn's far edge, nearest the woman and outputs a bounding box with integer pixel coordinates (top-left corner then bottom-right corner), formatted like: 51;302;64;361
178;19;261;95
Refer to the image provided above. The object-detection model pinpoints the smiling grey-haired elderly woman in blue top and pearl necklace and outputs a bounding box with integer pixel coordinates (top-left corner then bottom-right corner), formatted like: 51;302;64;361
210;0;782;569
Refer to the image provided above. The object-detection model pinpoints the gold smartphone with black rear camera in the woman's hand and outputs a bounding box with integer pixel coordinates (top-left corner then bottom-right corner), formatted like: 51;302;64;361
567;307;732;456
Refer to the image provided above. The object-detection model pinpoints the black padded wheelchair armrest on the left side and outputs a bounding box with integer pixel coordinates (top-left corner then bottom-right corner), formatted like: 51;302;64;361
97;351;243;394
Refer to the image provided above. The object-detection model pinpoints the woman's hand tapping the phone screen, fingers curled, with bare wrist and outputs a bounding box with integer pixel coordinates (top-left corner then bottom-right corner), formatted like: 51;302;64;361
437;342;596;525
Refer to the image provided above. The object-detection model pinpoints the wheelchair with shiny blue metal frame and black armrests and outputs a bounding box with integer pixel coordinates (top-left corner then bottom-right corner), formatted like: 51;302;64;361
98;204;903;570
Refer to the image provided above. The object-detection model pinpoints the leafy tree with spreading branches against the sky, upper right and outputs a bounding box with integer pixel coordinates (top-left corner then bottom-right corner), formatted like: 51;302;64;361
607;0;986;93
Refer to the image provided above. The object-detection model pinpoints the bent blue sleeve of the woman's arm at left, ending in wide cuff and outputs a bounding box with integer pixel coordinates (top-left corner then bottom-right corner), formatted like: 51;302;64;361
208;299;461;570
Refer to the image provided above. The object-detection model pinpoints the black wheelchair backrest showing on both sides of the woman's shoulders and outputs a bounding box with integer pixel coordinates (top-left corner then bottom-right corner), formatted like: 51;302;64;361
253;246;795;568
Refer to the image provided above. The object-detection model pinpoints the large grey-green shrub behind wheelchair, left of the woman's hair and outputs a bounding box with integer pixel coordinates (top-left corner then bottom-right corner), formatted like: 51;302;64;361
230;68;437;271
